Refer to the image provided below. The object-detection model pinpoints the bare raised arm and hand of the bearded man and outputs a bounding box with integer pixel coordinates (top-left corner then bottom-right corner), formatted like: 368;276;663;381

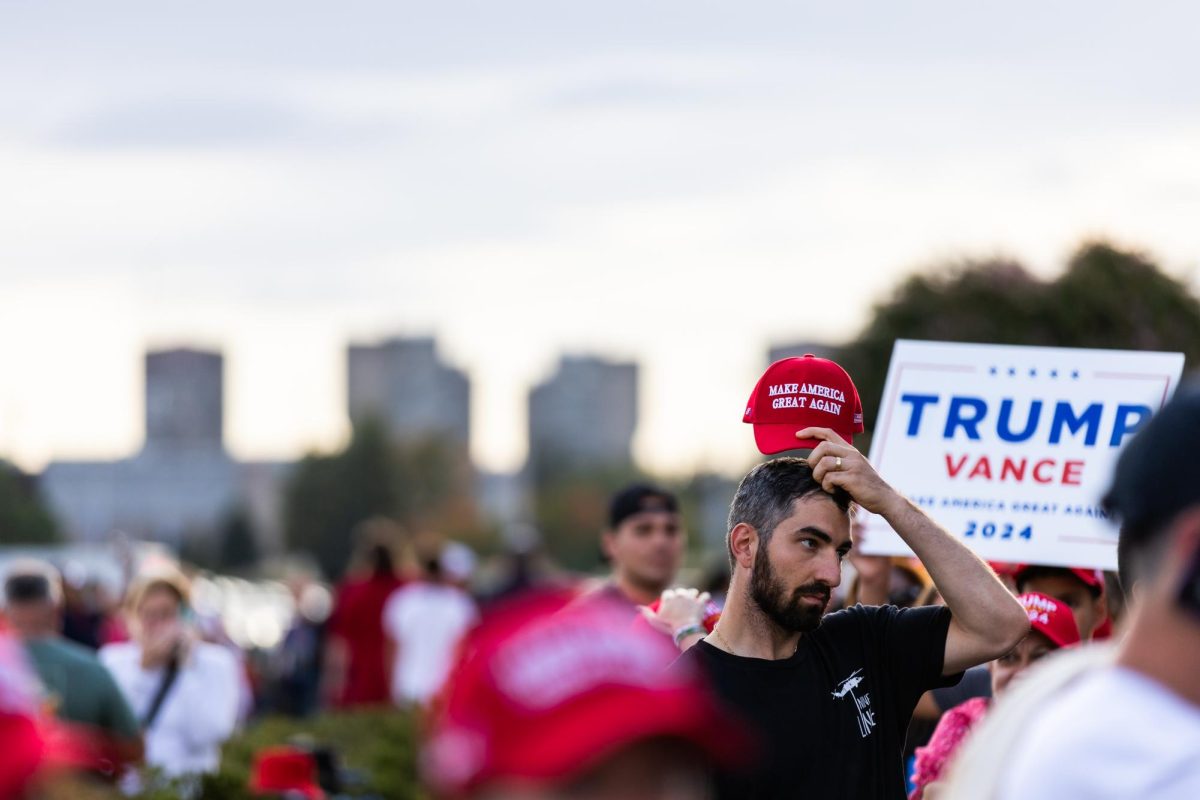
796;428;1030;675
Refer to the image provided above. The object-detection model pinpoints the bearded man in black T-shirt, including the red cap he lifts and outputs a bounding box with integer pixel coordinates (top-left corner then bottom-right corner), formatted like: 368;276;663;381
682;356;1030;800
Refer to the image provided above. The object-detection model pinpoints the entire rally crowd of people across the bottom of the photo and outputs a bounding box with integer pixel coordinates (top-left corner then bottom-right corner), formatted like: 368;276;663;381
7;392;1200;800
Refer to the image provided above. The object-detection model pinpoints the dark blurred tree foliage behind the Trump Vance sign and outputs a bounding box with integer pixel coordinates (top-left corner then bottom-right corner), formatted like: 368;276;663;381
839;242;1200;428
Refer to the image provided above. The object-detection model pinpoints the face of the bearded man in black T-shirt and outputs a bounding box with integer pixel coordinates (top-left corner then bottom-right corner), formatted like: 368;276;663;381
750;493;851;632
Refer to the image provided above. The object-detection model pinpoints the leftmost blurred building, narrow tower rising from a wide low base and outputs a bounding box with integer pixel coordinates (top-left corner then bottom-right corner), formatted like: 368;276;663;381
38;348;289;551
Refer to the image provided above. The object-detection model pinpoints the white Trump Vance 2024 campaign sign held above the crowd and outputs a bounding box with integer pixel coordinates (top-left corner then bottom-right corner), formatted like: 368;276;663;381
862;339;1183;570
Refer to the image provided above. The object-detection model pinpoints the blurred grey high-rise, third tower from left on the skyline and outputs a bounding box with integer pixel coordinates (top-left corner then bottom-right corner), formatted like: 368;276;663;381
529;355;637;475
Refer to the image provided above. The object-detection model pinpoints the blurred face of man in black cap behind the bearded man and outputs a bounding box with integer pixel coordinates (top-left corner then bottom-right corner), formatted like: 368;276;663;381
604;511;686;594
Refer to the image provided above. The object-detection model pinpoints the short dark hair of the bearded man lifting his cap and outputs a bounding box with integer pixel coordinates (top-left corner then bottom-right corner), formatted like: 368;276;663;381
726;457;853;564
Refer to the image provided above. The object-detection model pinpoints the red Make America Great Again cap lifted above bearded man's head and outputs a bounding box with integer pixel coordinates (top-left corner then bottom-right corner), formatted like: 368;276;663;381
742;353;863;456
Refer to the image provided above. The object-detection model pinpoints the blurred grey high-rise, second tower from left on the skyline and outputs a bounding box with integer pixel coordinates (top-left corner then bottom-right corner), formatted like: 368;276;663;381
346;337;470;450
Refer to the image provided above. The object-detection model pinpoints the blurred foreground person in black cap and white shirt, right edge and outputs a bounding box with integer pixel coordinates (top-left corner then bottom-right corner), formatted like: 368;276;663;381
984;385;1200;800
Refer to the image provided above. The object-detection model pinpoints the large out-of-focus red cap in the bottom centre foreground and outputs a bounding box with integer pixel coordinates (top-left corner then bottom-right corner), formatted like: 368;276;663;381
422;587;749;796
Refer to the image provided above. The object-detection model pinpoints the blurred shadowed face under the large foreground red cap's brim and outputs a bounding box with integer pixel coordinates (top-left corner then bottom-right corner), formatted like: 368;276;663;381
478;740;712;800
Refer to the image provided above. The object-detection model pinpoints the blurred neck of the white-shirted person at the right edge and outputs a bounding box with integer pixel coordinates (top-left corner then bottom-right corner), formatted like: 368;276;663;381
1117;609;1200;708
